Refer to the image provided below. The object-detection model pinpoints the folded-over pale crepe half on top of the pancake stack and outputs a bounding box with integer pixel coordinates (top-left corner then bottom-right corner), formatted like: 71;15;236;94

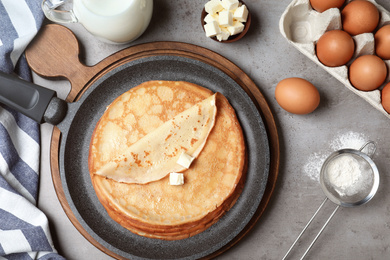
96;94;217;184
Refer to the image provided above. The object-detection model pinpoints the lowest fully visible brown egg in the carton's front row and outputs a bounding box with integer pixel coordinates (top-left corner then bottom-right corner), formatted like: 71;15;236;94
349;55;387;91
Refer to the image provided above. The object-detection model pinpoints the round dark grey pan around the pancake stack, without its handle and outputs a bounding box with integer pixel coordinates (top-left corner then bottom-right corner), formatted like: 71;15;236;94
58;56;270;259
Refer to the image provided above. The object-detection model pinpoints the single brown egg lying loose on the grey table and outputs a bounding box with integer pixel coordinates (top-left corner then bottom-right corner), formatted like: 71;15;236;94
275;78;320;115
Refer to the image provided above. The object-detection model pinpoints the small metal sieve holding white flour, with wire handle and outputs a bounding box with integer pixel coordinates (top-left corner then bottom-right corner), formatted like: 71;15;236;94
283;141;379;260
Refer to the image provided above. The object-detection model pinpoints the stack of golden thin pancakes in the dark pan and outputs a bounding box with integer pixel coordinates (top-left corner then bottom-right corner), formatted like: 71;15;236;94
89;81;247;240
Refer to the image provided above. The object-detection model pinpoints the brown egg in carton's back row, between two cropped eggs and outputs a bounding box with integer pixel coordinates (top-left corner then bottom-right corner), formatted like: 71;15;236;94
341;0;379;35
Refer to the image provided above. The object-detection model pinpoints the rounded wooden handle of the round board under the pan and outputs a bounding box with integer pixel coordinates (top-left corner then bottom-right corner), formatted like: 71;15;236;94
26;24;100;101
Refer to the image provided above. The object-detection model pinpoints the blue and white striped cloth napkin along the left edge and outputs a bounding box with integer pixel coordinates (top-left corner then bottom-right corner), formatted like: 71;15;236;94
0;0;64;259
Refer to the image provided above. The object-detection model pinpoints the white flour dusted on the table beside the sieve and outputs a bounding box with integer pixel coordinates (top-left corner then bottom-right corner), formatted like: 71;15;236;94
303;131;368;182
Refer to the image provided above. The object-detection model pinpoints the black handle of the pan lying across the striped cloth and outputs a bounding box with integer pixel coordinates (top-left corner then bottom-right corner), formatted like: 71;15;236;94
0;71;68;125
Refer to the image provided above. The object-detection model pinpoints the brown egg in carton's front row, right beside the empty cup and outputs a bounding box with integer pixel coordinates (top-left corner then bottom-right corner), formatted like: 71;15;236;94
316;30;355;67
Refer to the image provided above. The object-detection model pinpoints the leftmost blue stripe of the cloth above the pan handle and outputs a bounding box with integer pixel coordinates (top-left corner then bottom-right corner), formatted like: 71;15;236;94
0;1;18;73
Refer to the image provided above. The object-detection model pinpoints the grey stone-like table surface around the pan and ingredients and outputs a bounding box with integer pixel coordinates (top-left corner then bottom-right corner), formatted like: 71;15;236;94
34;0;390;260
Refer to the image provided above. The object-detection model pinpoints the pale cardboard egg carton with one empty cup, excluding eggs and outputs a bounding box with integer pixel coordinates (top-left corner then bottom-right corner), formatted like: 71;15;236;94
279;0;390;118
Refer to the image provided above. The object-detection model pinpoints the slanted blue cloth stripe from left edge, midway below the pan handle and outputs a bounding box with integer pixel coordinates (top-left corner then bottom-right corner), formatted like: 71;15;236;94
0;123;39;200
